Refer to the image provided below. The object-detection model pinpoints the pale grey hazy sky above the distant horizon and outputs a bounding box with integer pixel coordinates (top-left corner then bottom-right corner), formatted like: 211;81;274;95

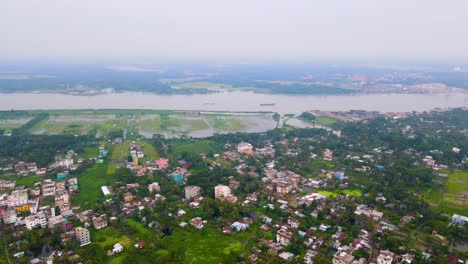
0;0;468;59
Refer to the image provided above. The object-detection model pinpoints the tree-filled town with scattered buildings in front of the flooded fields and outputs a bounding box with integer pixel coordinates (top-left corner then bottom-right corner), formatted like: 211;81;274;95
0;109;468;264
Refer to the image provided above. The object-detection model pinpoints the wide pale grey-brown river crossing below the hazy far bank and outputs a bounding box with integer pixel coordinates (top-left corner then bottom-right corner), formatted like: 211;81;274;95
0;92;468;114
